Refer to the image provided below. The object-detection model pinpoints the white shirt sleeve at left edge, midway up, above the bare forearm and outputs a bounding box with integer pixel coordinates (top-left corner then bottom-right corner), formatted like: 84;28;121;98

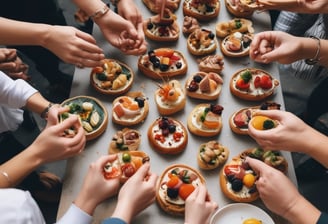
0;71;38;109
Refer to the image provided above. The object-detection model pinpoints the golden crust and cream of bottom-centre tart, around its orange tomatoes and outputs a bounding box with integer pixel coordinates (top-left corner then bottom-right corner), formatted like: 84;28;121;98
156;164;205;216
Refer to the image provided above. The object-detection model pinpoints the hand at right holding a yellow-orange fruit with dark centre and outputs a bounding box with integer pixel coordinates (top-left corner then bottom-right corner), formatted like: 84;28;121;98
248;110;312;152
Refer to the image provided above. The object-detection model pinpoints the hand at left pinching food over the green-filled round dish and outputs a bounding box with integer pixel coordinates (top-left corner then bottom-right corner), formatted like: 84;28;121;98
27;105;86;164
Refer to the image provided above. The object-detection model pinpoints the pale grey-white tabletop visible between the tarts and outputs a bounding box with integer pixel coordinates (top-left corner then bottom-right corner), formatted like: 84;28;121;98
57;0;297;224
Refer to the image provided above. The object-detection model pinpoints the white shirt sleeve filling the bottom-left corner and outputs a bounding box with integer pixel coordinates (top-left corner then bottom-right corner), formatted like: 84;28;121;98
0;188;45;224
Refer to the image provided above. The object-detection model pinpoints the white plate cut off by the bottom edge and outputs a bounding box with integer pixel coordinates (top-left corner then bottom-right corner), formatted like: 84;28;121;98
210;203;274;224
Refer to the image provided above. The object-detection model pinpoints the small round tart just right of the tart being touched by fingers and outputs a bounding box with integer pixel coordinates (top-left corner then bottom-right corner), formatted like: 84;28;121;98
187;29;218;56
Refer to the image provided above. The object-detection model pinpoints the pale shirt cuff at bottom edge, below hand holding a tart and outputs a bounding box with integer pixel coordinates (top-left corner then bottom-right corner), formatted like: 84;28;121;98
56;204;93;224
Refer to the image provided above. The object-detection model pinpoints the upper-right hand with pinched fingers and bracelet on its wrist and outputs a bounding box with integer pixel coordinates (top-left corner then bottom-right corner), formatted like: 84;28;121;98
249;31;302;64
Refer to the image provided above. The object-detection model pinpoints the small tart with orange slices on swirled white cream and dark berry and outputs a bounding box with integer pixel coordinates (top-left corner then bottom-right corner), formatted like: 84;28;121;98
112;92;149;126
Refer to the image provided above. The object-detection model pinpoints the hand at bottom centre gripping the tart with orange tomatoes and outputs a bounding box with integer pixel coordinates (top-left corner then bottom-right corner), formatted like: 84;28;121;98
185;185;218;224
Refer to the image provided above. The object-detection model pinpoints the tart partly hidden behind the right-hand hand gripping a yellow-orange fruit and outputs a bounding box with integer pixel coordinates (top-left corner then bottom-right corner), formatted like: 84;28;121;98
229;101;281;135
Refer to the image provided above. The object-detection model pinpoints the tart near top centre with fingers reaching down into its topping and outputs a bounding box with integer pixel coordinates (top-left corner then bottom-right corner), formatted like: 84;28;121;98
143;9;180;42
